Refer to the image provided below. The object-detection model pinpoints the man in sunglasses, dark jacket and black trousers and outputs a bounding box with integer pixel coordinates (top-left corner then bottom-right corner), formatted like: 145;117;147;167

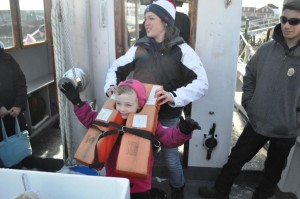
198;0;300;199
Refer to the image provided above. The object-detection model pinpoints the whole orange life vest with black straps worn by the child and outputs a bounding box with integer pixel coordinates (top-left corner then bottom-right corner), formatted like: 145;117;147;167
74;84;161;176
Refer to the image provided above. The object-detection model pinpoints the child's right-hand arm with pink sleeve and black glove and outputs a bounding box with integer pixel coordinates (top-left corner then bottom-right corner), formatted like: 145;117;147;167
155;117;201;148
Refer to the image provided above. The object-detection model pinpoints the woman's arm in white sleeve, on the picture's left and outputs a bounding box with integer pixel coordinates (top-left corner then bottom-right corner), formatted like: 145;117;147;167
104;46;137;96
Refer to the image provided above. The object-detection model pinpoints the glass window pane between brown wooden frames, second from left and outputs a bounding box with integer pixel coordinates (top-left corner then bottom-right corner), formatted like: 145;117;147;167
19;0;46;45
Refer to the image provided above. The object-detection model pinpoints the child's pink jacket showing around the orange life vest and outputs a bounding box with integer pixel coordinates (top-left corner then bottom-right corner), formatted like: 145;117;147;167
74;102;192;193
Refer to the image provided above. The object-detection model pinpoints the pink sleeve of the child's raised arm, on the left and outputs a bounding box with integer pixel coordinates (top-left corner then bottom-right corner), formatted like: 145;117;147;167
74;102;98;128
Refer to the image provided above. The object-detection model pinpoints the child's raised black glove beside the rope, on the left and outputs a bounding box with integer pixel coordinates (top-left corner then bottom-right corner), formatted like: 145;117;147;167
60;82;83;107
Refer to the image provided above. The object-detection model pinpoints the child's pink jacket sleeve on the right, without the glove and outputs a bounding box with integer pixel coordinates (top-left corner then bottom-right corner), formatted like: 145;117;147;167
155;122;192;148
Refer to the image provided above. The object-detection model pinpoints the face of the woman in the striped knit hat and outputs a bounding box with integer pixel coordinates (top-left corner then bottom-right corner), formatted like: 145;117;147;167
145;12;166;42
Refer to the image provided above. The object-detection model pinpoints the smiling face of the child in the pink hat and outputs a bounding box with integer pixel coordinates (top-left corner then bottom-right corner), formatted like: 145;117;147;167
116;92;139;119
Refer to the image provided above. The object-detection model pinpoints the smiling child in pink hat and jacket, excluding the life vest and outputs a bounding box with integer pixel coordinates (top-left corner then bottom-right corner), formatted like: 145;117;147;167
61;79;200;199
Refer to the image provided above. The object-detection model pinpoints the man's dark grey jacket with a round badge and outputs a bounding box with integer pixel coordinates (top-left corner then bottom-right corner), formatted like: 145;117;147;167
242;24;300;138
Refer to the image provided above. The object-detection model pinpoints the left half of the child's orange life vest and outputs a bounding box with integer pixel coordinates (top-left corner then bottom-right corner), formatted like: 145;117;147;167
74;95;124;170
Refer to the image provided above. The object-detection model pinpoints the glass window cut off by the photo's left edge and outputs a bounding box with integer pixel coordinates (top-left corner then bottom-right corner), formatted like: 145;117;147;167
0;0;15;48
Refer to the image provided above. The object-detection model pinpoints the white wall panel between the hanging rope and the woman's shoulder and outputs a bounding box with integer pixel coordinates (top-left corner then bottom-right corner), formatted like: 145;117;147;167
90;0;115;107
